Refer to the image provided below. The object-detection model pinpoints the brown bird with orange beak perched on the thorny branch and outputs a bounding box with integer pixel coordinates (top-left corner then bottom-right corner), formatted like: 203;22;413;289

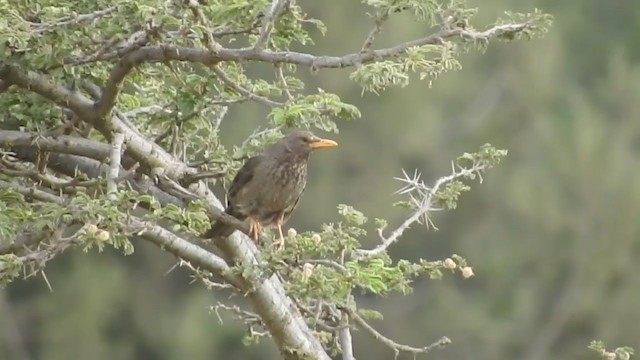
204;130;338;248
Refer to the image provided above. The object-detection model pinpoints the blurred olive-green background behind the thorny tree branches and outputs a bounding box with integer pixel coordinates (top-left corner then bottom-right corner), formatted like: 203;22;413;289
5;0;640;360
